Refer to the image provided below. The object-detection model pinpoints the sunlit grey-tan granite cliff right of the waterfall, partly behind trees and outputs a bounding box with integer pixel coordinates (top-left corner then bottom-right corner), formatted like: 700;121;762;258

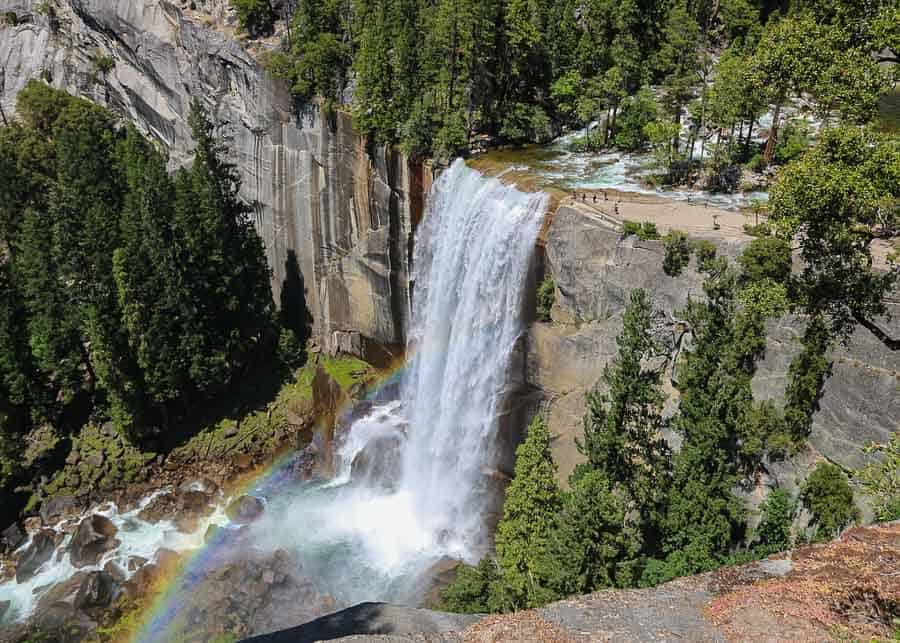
526;205;900;487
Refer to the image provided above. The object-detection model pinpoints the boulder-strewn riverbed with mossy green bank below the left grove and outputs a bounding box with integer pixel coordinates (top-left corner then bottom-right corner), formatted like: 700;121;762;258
0;355;375;643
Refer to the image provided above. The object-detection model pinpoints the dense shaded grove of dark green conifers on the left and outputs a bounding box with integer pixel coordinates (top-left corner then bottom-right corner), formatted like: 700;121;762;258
0;81;277;484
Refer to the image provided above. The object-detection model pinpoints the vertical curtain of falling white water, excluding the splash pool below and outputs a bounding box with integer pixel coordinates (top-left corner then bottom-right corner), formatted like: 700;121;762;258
400;161;547;557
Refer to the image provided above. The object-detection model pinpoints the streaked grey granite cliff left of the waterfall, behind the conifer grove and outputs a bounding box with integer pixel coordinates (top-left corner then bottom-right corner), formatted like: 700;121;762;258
0;0;429;362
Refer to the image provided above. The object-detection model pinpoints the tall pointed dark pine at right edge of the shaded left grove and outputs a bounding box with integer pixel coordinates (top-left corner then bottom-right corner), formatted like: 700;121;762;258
174;102;274;393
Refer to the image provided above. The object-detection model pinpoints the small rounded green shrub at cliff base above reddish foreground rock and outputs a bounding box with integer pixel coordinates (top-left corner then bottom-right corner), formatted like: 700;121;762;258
801;463;859;541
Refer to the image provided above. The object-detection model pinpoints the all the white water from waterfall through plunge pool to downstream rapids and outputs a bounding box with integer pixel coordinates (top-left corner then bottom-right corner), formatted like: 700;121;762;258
0;161;548;642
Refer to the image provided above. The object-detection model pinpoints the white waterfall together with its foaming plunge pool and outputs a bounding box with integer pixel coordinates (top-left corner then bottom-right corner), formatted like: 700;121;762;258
270;161;547;603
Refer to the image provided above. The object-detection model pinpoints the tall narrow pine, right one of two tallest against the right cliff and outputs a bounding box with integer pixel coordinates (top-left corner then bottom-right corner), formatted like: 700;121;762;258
663;259;752;575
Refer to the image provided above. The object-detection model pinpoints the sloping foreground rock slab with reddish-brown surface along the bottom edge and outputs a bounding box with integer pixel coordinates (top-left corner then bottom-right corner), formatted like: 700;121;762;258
241;522;900;643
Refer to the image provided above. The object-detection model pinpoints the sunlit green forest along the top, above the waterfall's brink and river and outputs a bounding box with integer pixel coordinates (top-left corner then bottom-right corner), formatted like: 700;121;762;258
256;0;897;172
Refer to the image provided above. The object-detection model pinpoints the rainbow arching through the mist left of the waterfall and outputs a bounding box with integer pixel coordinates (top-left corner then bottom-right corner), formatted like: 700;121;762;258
128;361;408;643
